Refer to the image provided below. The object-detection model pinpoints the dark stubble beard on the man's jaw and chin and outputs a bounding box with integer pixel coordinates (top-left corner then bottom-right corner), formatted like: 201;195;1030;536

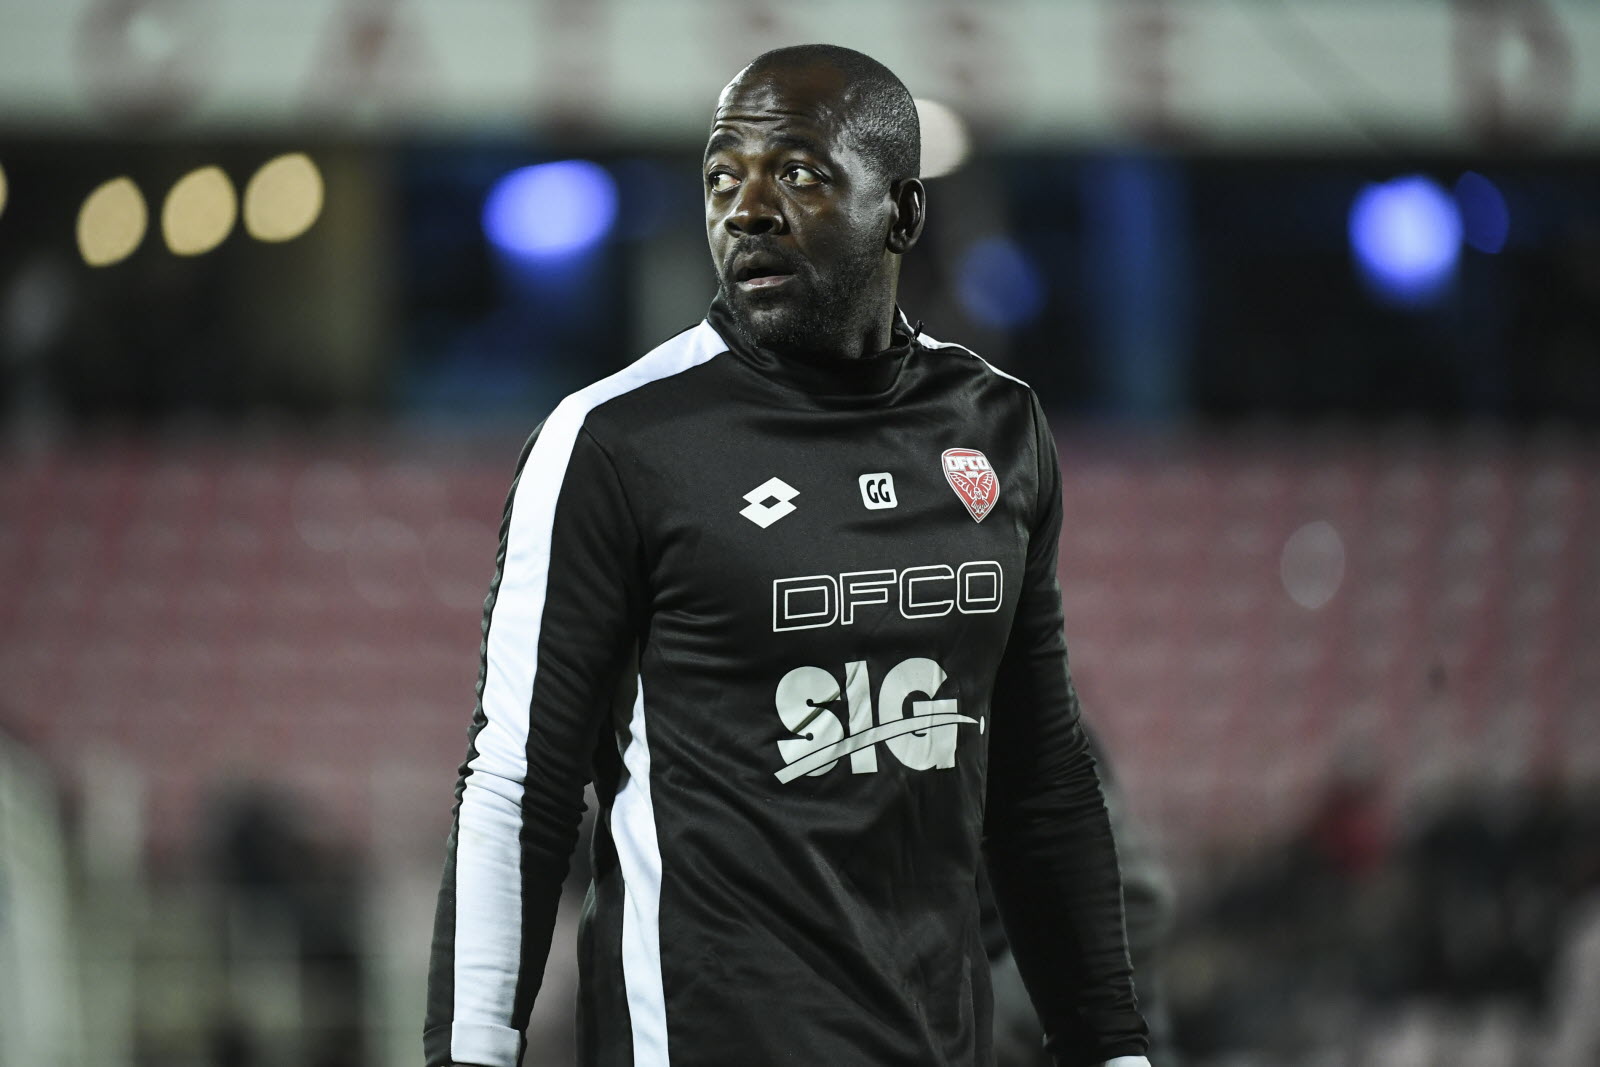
718;241;883;355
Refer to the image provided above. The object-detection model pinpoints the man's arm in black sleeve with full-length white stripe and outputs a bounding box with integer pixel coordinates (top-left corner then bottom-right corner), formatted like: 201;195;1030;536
424;415;642;1067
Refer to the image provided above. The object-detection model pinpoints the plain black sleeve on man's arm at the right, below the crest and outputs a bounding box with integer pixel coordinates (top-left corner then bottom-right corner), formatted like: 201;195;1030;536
984;400;1147;1067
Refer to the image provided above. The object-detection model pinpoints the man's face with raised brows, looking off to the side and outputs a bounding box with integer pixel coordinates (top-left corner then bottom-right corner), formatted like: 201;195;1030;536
704;66;894;350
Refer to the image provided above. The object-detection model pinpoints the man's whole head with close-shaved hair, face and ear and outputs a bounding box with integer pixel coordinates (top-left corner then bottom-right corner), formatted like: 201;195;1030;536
704;45;926;358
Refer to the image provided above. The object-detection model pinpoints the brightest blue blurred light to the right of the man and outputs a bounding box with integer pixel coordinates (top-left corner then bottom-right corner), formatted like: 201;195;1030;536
1350;174;1461;304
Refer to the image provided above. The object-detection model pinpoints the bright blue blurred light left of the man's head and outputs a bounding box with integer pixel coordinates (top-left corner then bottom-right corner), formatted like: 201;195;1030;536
483;160;616;259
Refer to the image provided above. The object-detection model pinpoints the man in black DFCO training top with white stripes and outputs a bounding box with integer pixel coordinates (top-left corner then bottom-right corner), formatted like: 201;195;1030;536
426;45;1146;1067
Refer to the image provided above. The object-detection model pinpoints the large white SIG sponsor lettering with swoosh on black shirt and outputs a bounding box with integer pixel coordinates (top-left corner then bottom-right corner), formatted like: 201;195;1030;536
773;656;984;784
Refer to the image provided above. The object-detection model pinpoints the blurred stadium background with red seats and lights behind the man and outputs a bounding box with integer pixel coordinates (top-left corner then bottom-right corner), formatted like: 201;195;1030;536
0;0;1600;1067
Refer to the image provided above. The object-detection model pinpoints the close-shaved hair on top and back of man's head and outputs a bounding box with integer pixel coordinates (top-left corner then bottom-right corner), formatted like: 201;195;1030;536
725;45;922;182
